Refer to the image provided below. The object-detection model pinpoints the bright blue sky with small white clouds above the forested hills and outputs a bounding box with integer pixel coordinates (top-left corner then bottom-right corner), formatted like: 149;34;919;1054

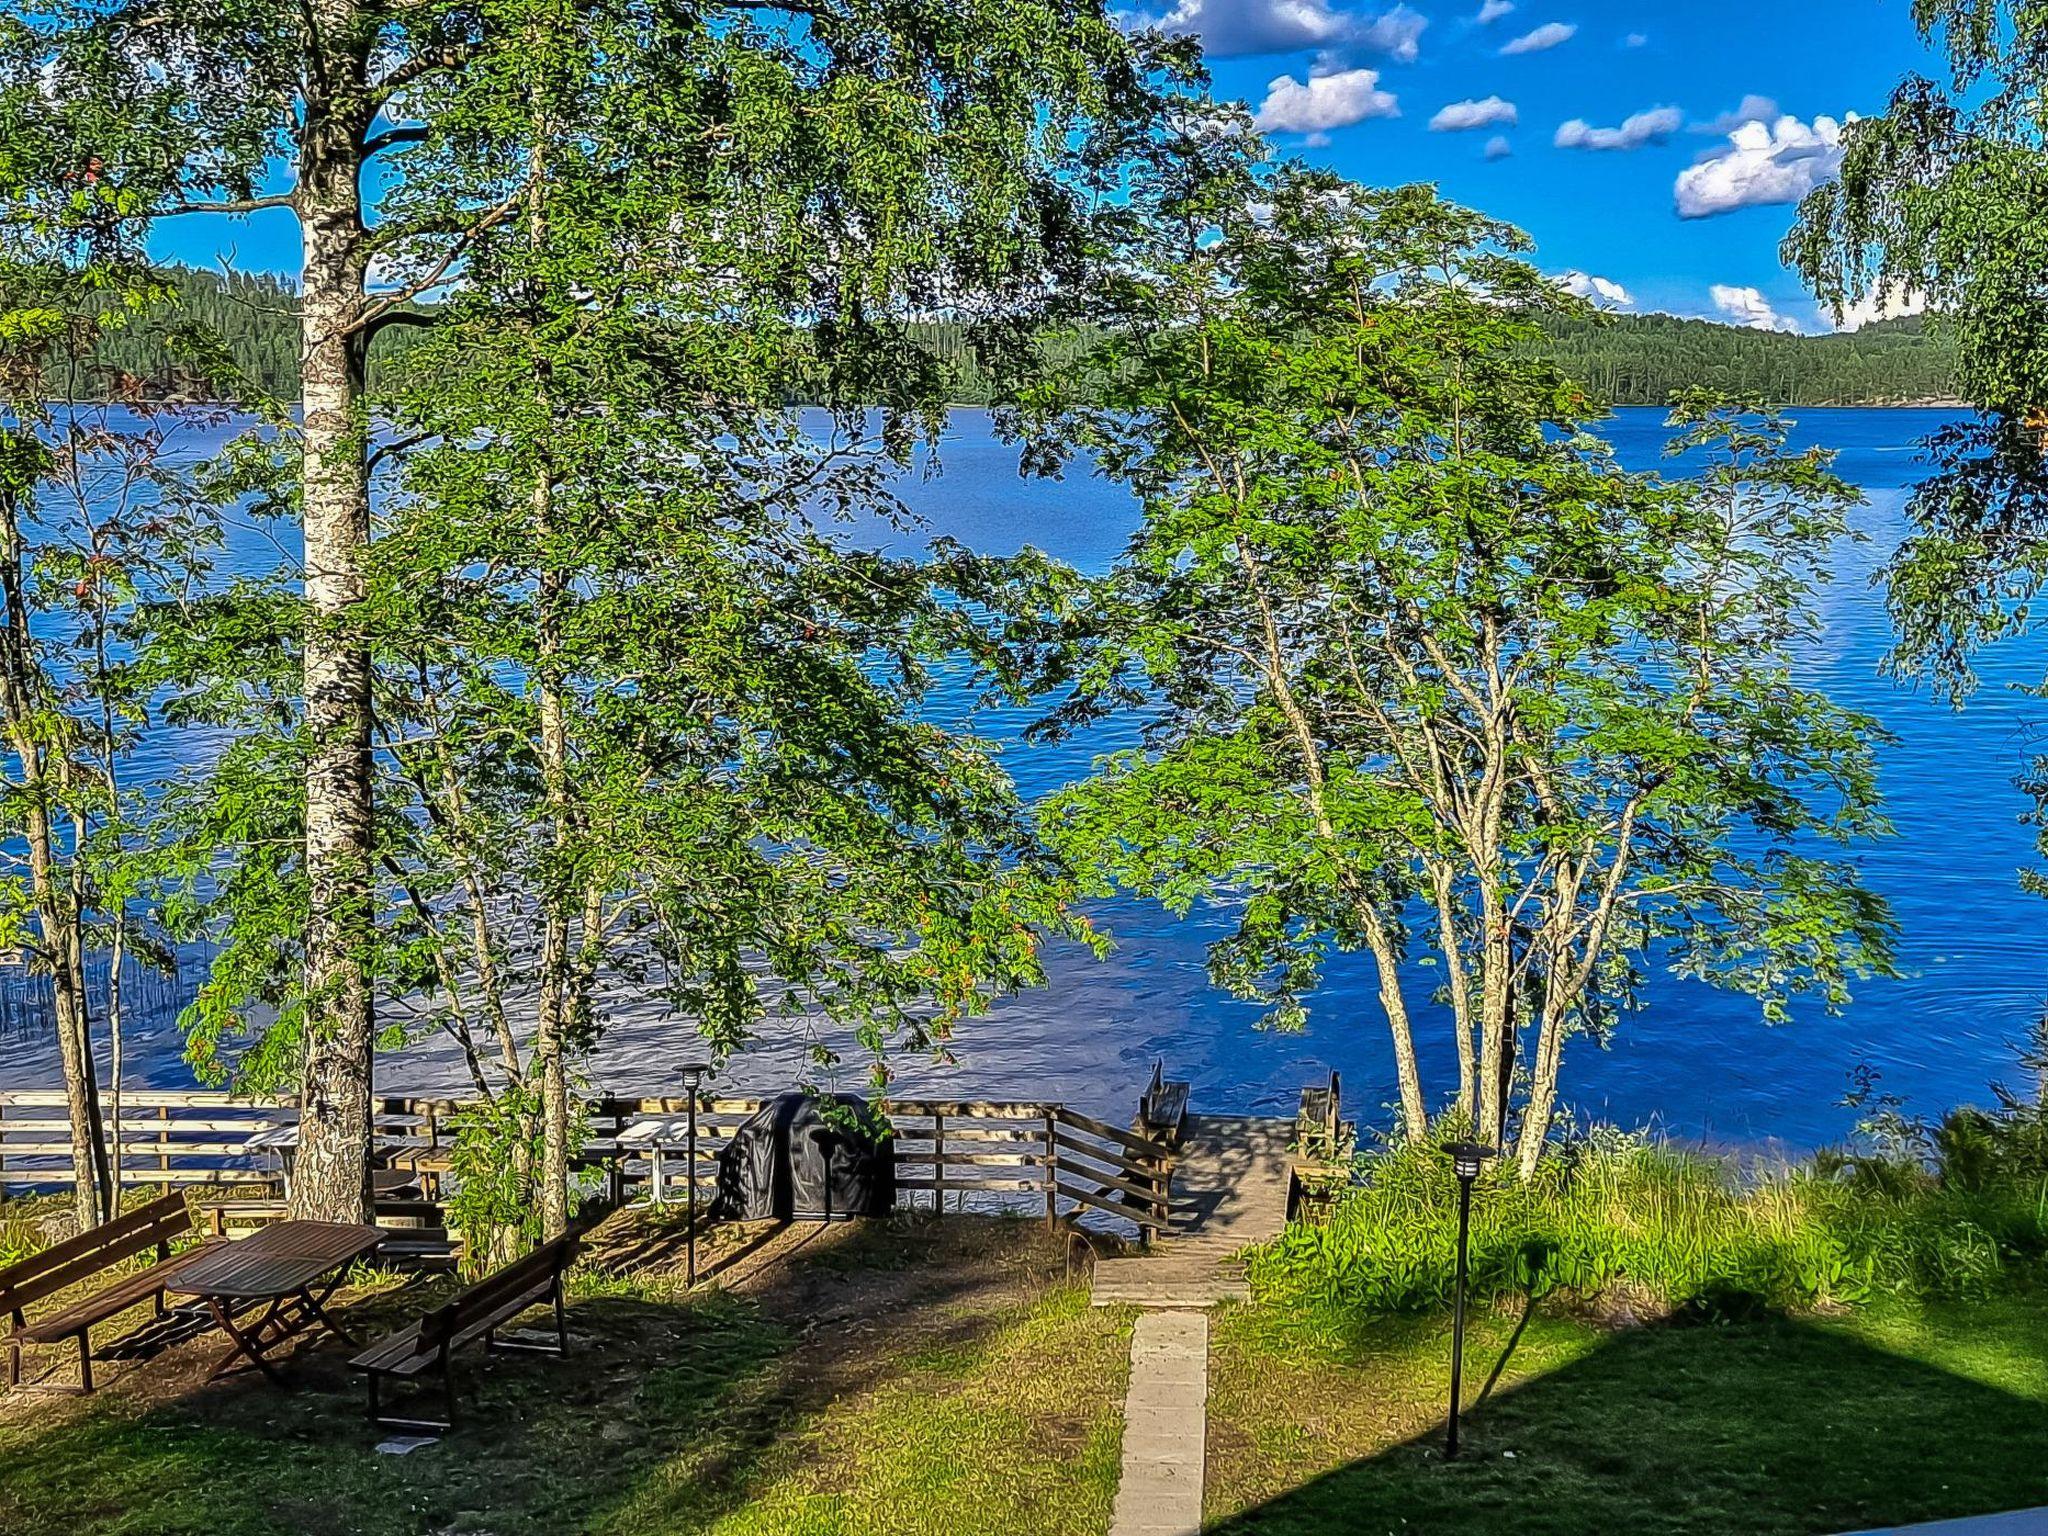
158;0;1939;330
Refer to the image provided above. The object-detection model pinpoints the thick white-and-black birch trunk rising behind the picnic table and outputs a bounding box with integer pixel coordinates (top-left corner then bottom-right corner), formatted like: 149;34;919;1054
291;0;377;1221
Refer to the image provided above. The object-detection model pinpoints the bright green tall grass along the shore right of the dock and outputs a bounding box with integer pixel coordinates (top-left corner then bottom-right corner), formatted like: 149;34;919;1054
1251;1137;2048;1313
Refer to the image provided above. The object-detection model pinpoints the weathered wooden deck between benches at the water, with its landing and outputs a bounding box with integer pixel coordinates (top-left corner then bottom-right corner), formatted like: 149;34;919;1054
1094;1114;1294;1309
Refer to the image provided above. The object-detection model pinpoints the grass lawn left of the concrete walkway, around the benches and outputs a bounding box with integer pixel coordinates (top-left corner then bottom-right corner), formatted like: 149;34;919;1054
0;1217;1130;1536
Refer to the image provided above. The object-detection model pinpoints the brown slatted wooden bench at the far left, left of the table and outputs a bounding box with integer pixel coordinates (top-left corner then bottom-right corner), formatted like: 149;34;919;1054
0;1194;212;1395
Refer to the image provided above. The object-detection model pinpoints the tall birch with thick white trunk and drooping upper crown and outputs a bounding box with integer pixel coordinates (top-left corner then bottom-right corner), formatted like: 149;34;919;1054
0;0;1196;1219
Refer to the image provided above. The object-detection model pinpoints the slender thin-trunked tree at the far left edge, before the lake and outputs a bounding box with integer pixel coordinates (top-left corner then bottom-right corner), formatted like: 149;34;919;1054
0;259;213;1231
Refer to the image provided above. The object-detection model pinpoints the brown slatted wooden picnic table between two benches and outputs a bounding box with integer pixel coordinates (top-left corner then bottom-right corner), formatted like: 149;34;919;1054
166;1221;385;1386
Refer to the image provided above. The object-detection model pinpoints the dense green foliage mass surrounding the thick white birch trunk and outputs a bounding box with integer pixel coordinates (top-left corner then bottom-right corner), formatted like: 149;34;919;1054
0;0;1198;1122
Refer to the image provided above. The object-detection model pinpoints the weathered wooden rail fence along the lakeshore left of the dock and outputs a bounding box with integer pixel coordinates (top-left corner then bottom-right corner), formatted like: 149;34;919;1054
0;1092;1174;1237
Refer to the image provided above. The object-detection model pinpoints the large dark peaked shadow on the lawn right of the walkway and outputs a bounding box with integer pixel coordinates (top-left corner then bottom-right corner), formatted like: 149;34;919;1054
1206;1311;2048;1536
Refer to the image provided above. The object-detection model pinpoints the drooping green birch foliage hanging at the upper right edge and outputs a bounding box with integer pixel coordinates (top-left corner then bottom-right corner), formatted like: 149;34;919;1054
1786;0;2048;700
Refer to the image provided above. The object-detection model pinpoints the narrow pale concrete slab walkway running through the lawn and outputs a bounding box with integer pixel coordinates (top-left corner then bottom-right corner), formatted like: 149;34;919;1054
1110;1313;1208;1536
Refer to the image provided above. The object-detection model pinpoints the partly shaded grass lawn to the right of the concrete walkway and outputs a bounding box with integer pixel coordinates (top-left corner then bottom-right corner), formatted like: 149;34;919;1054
1206;1294;2048;1536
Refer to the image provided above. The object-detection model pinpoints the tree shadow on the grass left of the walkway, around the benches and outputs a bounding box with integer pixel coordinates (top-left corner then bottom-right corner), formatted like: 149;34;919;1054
0;1225;1081;1536
